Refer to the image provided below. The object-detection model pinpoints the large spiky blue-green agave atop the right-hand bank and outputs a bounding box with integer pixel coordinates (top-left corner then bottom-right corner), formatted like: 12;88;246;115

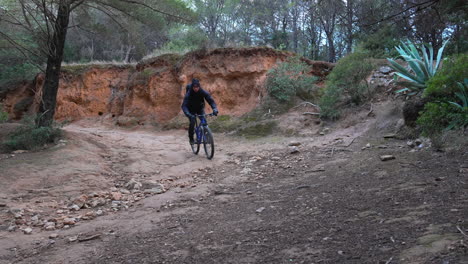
387;41;448;94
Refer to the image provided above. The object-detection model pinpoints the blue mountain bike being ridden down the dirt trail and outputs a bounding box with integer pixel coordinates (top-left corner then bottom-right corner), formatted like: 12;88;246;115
190;113;214;159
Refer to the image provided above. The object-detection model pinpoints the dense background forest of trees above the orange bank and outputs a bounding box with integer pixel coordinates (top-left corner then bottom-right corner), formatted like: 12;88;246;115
0;0;468;74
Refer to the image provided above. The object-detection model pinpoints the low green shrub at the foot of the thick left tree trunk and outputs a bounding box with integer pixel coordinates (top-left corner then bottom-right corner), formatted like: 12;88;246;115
3;116;62;151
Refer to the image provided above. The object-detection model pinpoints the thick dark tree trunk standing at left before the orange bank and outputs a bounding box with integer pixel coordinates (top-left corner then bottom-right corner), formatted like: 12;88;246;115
36;0;71;127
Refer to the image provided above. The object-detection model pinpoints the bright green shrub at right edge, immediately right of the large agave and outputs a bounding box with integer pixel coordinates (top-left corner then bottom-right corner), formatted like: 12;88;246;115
424;53;468;100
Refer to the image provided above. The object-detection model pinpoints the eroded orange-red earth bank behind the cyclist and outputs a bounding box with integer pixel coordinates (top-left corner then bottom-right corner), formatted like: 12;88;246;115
5;47;333;124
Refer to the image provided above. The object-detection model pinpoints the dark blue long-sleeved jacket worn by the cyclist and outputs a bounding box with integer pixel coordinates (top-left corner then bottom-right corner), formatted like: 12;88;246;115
182;85;217;115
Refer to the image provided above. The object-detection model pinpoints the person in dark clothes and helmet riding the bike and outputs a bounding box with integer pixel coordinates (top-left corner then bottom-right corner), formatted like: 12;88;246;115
182;79;218;144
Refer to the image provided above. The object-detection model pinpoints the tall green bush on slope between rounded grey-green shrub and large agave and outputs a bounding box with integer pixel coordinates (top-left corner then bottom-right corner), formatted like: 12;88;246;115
319;52;375;120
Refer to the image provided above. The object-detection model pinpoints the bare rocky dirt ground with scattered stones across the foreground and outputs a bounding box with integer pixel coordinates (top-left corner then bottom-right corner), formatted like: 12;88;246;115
0;102;468;264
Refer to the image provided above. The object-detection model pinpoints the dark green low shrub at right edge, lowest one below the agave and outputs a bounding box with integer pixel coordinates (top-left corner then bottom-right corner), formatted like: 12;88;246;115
416;102;468;138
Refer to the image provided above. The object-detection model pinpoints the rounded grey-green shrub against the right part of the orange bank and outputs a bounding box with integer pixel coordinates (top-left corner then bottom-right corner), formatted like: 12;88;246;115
267;57;317;102
